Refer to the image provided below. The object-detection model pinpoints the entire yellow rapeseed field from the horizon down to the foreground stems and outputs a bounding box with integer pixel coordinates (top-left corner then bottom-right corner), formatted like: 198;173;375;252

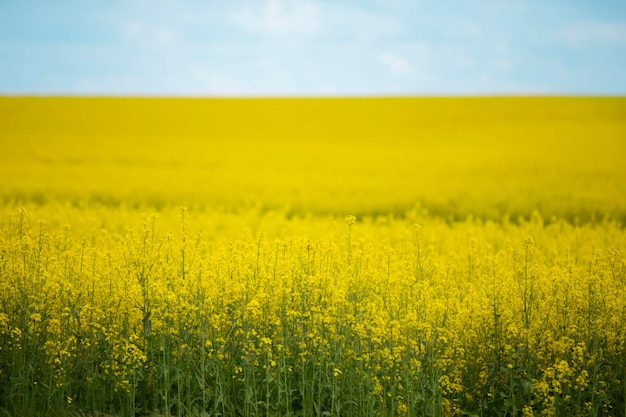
0;97;626;417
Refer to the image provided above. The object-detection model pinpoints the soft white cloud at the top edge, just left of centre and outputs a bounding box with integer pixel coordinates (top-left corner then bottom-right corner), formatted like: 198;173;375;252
233;0;319;35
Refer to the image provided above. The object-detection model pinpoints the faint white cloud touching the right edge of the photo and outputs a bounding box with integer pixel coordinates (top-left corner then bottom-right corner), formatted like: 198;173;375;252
560;21;626;47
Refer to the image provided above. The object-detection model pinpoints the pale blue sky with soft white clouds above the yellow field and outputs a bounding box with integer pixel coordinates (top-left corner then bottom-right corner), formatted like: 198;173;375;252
0;0;626;96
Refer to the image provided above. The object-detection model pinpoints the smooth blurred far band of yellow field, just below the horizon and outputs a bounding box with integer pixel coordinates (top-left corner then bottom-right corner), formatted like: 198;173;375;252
0;98;626;219
